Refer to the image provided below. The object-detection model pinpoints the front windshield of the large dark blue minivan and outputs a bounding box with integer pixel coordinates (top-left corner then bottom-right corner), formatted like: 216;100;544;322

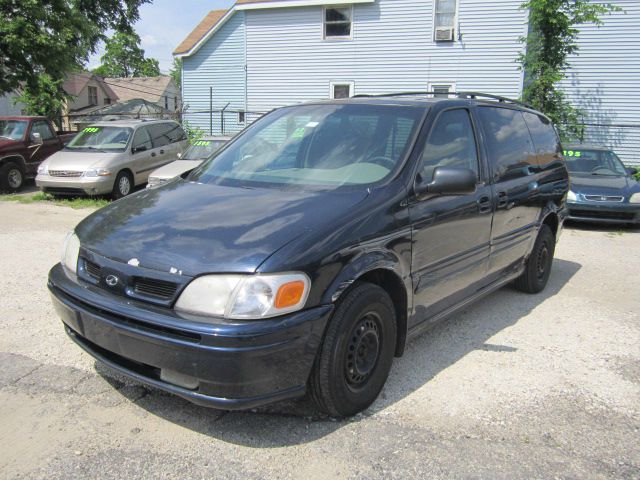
189;104;424;189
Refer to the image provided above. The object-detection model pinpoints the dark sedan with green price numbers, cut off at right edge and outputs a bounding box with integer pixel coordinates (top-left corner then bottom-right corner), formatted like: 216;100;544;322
564;145;640;224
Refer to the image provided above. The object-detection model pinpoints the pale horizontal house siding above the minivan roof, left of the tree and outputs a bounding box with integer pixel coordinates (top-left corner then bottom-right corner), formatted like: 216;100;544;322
245;0;527;111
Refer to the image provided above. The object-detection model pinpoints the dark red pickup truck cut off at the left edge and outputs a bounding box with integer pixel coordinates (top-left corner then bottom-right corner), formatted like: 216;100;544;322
0;117;76;192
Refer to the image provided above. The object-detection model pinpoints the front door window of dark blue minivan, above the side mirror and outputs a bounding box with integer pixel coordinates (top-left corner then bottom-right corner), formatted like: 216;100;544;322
420;109;478;180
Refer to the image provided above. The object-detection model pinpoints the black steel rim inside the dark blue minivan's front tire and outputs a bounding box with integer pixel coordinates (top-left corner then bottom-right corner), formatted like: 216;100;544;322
345;312;381;388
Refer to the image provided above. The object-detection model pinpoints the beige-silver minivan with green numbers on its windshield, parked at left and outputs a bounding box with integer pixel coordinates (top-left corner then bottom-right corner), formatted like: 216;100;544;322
36;120;188;198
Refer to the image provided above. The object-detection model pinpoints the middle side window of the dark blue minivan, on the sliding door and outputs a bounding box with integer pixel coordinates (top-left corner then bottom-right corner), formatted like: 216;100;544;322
478;107;535;181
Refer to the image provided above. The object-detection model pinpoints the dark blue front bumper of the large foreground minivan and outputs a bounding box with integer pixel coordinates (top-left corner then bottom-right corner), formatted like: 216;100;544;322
48;264;333;410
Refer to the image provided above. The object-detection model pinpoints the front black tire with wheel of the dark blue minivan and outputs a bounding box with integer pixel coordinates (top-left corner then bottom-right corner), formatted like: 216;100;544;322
309;282;397;417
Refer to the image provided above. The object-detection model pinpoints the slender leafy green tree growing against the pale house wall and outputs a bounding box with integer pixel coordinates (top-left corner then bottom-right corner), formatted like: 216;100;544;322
519;0;621;139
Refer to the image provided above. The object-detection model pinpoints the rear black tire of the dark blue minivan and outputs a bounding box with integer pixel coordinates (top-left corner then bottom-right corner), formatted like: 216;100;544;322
514;225;556;293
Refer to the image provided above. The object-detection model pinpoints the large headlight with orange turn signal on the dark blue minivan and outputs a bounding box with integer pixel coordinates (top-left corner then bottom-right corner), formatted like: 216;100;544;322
175;273;311;320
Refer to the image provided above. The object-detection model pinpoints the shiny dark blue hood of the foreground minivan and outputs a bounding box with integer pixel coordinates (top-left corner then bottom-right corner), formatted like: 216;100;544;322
76;180;368;276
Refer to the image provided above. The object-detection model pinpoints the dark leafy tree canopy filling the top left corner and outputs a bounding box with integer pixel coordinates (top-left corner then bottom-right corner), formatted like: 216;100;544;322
0;0;150;93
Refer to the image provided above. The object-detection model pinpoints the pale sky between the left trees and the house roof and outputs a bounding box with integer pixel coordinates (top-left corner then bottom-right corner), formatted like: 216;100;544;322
89;0;234;73
